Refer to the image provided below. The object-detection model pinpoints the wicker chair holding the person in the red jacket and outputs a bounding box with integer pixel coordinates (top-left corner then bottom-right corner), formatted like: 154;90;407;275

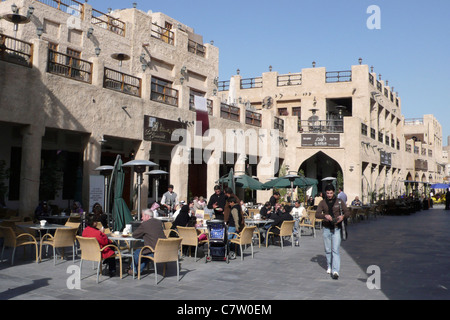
76;236;122;283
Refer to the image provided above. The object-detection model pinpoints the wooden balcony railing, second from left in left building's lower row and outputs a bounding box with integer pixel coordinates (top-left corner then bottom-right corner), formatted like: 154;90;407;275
47;49;92;83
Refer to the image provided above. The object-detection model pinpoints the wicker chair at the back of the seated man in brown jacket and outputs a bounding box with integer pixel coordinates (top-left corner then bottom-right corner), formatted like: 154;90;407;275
138;238;183;284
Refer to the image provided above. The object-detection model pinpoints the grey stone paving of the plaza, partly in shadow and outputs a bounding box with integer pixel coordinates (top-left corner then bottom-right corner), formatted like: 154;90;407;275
0;206;450;301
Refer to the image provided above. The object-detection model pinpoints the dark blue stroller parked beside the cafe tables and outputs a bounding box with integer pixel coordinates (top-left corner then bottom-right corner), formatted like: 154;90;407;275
205;220;230;263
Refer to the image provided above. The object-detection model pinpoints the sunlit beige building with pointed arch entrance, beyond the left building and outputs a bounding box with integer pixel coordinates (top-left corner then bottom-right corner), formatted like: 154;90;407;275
219;63;445;203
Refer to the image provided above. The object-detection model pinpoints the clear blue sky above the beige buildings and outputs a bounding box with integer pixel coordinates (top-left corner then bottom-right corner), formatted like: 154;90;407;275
89;0;450;145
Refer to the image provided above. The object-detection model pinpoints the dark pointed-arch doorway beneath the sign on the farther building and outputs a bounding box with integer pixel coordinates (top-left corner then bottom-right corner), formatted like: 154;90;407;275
299;151;343;192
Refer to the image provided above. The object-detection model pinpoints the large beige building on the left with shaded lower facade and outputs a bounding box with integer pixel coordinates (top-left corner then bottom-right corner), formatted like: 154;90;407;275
0;0;282;215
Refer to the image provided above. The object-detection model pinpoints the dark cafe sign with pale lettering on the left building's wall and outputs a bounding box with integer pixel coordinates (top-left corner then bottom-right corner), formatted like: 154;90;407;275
144;116;187;145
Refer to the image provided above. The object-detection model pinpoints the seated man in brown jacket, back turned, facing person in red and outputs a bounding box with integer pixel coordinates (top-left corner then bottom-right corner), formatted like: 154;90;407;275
132;209;166;275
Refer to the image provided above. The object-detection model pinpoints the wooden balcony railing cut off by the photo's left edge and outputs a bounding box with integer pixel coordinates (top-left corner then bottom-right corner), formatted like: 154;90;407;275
0;34;33;68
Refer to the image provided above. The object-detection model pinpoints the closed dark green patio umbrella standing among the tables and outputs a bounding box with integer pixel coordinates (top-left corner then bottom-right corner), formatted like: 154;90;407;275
109;155;133;231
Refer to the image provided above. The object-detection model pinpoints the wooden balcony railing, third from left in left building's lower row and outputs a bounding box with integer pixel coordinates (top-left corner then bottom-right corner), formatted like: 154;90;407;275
103;68;142;97
